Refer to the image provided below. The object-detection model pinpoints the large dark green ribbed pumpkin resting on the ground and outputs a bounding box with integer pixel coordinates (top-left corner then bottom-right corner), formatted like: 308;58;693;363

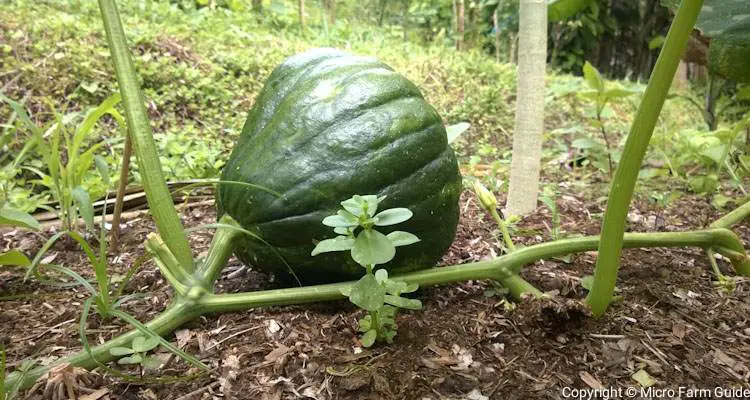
218;49;461;283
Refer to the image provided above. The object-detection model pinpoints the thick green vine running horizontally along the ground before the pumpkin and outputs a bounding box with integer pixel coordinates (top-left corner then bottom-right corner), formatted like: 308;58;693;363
7;225;750;387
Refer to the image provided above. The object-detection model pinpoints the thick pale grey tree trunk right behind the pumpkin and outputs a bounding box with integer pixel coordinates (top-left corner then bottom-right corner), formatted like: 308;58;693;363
506;0;547;215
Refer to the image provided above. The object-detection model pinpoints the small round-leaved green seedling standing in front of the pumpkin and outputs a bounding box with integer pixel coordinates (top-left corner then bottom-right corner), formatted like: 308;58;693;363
312;195;422;347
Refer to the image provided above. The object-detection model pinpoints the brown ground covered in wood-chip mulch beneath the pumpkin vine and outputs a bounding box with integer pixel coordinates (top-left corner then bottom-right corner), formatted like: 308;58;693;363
0;189;750;400
